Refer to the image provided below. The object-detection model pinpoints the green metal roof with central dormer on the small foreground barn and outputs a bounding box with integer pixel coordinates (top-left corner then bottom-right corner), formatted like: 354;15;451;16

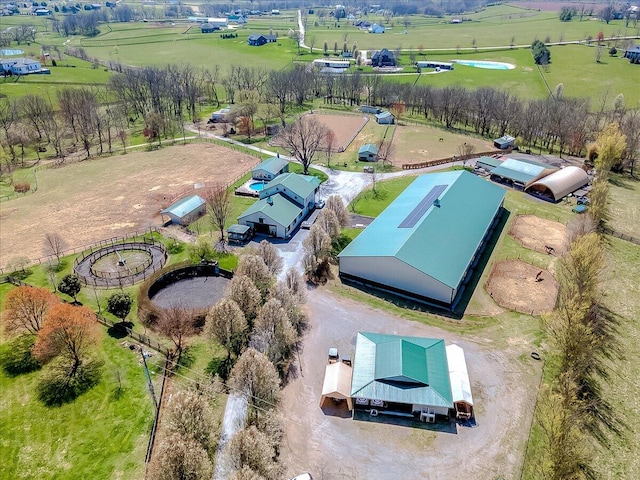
351;332;453;408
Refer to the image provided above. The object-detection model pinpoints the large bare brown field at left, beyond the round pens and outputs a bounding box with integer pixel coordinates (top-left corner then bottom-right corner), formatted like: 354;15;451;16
0;143;258;267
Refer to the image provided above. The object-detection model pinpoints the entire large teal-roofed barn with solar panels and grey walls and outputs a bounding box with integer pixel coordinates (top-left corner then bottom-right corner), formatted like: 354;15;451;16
338;170;506;309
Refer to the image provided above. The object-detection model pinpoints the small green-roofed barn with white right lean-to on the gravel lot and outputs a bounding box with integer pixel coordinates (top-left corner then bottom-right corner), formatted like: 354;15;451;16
351;332;472;422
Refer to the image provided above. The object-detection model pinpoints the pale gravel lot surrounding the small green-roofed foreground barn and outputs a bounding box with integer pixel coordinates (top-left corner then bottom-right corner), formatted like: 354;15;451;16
281;289;541;480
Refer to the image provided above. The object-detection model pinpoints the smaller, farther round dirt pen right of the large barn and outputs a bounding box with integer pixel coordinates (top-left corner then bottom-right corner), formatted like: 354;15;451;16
509;215;567;255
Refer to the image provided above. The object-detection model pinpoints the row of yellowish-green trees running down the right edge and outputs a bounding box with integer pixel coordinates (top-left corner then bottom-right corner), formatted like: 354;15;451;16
536;124;626;480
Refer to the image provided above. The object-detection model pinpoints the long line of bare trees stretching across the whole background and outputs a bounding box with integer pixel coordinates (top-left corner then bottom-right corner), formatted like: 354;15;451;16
0;60;640;178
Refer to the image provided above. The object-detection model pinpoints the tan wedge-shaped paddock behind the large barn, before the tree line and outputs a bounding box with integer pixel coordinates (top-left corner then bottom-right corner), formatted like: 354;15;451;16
392;125;495;167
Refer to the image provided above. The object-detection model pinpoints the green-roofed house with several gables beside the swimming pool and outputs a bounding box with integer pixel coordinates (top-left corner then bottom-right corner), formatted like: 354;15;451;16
238;173;320;238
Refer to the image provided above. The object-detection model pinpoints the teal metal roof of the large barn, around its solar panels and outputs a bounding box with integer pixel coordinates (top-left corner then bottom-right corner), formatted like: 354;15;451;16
339;170;505;288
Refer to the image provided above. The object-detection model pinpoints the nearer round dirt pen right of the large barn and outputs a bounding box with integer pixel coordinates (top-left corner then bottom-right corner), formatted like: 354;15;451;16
485;260;558;315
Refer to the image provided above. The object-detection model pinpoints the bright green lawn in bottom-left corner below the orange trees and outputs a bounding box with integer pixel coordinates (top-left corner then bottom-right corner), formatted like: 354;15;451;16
0;335;153;480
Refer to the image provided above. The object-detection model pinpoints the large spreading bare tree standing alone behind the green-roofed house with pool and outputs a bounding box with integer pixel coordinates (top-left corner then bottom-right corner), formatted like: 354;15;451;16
278;115;327;175
